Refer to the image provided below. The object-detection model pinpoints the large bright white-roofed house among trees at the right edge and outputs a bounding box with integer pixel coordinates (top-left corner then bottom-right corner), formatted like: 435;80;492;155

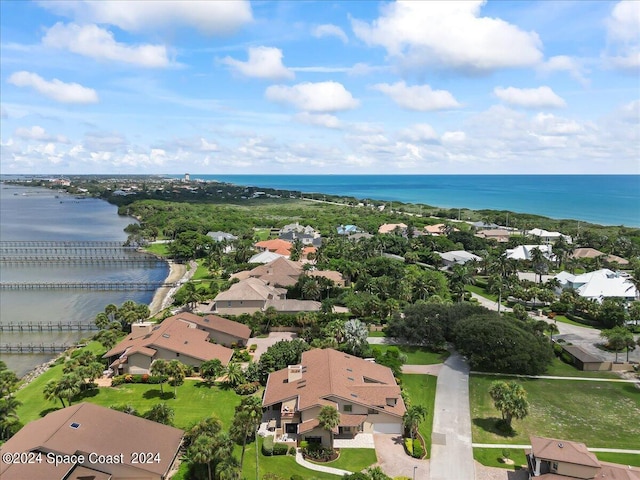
555;268;638;302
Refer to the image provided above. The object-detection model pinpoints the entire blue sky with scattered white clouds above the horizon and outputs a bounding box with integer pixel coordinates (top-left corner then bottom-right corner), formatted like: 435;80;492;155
0;0;640;174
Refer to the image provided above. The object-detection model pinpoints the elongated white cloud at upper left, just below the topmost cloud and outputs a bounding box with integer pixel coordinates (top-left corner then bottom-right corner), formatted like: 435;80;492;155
42;23;170;68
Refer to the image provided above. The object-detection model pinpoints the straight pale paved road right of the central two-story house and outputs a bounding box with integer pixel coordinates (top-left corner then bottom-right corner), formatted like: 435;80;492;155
430;352;475;480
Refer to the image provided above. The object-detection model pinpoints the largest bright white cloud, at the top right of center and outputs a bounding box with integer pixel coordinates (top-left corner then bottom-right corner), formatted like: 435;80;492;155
352;0;542;72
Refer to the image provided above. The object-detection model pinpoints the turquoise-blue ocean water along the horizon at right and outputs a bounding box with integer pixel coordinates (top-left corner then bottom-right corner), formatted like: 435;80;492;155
181;173;640;227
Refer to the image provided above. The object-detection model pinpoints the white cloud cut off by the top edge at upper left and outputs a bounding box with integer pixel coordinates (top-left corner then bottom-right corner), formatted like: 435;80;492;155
40;0;253;35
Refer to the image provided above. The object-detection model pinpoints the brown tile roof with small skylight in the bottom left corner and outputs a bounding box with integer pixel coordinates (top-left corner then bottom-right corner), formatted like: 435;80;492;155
0;403;184;480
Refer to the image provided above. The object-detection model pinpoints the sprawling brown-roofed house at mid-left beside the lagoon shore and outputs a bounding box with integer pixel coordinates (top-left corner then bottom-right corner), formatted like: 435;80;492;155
102;314;233;374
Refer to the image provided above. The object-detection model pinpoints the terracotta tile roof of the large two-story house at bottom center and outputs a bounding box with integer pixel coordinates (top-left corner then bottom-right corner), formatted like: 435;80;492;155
262;348;406;417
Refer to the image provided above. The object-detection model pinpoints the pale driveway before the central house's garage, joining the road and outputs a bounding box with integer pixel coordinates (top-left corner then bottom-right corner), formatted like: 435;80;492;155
373;433;429;480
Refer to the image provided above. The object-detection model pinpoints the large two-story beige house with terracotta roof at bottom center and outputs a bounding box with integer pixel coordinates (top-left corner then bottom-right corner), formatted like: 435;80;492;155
262;348;406;445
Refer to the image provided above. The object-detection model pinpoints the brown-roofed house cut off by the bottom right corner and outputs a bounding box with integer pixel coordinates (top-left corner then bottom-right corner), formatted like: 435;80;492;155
525;437;640;480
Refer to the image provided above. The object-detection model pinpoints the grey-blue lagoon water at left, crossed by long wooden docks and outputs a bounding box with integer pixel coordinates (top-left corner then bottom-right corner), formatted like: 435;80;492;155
0;184;168;375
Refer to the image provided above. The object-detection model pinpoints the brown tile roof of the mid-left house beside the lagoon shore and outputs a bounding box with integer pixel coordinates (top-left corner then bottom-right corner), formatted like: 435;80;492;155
102;314;233;365
